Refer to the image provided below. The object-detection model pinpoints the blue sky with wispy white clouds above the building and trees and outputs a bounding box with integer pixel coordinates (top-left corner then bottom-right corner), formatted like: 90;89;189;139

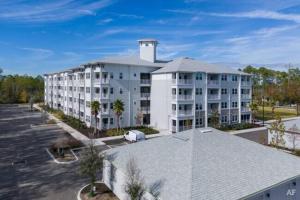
0;0;300;75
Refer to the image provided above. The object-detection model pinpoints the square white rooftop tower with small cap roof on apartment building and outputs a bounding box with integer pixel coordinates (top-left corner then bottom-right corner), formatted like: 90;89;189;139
138;39;158;63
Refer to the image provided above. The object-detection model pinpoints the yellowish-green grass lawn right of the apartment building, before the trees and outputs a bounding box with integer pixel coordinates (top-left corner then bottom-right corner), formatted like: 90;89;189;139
256;106;297;121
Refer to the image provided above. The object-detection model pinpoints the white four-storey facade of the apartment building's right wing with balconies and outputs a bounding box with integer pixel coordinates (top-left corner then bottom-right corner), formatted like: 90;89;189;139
151;72;252;132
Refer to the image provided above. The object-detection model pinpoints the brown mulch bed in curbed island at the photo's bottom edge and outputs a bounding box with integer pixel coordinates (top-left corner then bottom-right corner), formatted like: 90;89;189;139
80;183;119;200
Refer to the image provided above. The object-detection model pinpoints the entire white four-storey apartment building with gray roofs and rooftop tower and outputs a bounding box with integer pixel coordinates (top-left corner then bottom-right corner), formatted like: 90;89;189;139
44;39;251;132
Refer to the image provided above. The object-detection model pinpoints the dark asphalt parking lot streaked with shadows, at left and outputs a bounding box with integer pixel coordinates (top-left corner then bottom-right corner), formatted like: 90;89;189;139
0;105;87;200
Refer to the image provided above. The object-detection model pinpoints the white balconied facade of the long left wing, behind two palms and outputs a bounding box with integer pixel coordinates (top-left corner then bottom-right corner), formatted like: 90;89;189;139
45;64;158;129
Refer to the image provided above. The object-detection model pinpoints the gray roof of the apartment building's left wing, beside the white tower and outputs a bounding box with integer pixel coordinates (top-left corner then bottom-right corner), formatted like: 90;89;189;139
89;55;168;68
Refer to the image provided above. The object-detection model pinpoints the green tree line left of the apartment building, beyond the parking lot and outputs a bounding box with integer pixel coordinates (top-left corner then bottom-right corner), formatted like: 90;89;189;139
0;68;44;103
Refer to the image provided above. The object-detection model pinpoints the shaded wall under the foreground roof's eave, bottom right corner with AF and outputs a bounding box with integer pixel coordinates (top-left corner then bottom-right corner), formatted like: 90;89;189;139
246;178;300;200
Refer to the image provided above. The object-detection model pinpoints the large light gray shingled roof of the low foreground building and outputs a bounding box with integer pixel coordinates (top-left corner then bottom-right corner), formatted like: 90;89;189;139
107;129;300;200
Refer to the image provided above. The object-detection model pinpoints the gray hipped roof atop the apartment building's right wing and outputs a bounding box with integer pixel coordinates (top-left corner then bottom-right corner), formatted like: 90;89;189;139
153;57;246;74
